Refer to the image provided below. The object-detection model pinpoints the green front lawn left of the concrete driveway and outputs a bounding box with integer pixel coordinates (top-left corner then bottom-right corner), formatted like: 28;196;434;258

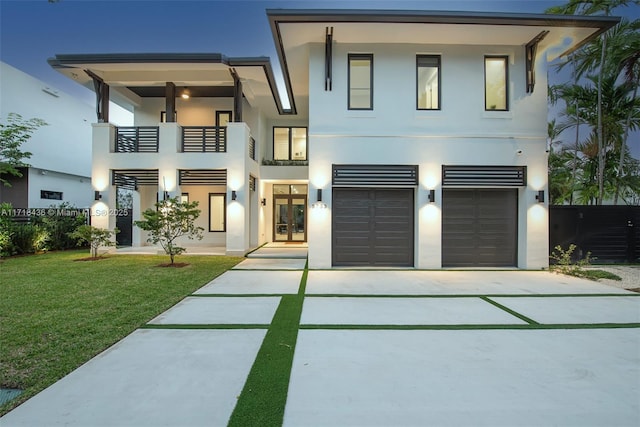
0;251;243;415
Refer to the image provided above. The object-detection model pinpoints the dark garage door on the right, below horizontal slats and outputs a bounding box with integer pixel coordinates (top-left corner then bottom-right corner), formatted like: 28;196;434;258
442;189;518;267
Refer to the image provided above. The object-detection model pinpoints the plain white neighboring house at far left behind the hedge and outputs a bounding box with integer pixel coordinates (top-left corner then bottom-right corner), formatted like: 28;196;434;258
0;62;95;209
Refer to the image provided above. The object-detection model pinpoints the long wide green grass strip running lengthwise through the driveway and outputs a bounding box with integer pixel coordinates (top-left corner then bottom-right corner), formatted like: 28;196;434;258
228;266;308;427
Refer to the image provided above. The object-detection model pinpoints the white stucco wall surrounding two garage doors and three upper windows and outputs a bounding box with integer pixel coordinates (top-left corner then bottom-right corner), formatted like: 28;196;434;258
308;43;548;269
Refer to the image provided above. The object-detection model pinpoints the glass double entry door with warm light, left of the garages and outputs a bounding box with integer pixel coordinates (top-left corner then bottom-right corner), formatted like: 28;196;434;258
273;194;307;242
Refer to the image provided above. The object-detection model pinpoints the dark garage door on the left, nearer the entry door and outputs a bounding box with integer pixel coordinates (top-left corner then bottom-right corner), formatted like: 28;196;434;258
332;188;414;267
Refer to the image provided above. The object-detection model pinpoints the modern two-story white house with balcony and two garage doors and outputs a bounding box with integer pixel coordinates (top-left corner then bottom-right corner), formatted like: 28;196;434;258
49;10;618;269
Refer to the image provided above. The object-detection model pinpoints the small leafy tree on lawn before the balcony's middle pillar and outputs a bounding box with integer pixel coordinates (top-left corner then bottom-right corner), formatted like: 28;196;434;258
135;197;204;264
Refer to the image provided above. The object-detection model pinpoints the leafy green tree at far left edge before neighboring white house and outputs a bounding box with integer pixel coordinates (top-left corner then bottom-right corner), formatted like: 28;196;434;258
0;113;47;187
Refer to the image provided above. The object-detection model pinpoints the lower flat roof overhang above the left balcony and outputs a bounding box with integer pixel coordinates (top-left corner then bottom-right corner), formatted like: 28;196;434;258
48;53;290;114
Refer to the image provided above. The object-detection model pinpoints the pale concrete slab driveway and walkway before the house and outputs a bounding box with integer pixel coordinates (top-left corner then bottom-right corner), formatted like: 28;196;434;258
0;258;640;427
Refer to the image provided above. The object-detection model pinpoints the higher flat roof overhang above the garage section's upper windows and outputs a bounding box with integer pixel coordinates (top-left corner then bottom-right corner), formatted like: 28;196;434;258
267;9;620;114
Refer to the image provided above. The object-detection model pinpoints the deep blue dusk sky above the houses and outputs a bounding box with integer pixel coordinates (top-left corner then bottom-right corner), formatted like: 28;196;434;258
0;0;640;153
